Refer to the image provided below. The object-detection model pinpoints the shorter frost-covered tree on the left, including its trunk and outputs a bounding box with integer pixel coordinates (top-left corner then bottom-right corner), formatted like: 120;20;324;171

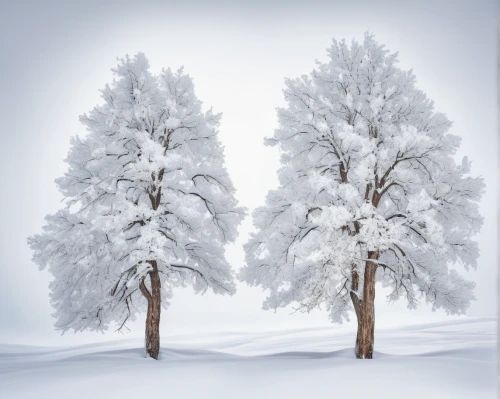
28;53;244;359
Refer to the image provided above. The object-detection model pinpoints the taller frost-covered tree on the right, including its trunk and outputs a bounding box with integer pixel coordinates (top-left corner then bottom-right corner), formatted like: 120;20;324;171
239;34;483;359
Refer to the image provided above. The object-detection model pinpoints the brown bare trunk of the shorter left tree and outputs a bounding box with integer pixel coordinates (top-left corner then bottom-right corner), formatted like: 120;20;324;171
140;260;161;360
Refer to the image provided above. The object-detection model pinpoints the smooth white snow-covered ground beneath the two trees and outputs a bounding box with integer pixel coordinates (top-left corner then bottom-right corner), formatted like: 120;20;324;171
0;319;497;399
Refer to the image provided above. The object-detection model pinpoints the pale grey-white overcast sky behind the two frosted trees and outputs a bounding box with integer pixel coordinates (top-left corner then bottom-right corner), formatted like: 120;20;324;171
0;0;497;345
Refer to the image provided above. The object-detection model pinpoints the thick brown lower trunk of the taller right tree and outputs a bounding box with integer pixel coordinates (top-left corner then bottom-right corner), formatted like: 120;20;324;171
356;251;378;359
